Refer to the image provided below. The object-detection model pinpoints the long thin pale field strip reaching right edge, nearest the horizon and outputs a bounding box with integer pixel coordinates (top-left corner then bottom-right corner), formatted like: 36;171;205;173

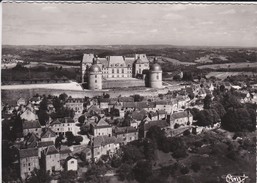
197;62;257;70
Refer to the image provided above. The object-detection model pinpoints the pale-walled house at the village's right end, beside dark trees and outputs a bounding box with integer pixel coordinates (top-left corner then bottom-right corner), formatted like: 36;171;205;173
169;111;193;129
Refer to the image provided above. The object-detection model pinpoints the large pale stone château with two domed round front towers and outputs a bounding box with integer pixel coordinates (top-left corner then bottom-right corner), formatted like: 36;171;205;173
81;53;162;90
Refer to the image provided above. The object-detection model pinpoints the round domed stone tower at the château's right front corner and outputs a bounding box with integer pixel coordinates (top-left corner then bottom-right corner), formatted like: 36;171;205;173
149;58;162;88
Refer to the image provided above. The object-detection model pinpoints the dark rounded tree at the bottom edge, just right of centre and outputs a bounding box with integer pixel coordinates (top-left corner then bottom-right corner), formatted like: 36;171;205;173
133;160;153;183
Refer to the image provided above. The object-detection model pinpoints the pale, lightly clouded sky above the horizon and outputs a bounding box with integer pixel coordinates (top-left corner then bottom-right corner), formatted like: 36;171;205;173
2;3;257;47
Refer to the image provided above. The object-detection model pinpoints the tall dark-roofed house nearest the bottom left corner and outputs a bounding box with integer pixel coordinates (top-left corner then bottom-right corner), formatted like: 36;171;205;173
19;148;39;180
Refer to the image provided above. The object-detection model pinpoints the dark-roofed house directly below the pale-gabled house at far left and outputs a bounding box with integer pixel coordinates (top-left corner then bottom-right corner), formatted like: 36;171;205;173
22;120;42;137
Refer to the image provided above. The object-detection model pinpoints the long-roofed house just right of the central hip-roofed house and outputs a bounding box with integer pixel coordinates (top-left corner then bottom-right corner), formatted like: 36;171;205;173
113;126;138;144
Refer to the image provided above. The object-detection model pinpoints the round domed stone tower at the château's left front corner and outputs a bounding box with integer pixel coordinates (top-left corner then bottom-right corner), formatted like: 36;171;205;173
88;58;102;90
